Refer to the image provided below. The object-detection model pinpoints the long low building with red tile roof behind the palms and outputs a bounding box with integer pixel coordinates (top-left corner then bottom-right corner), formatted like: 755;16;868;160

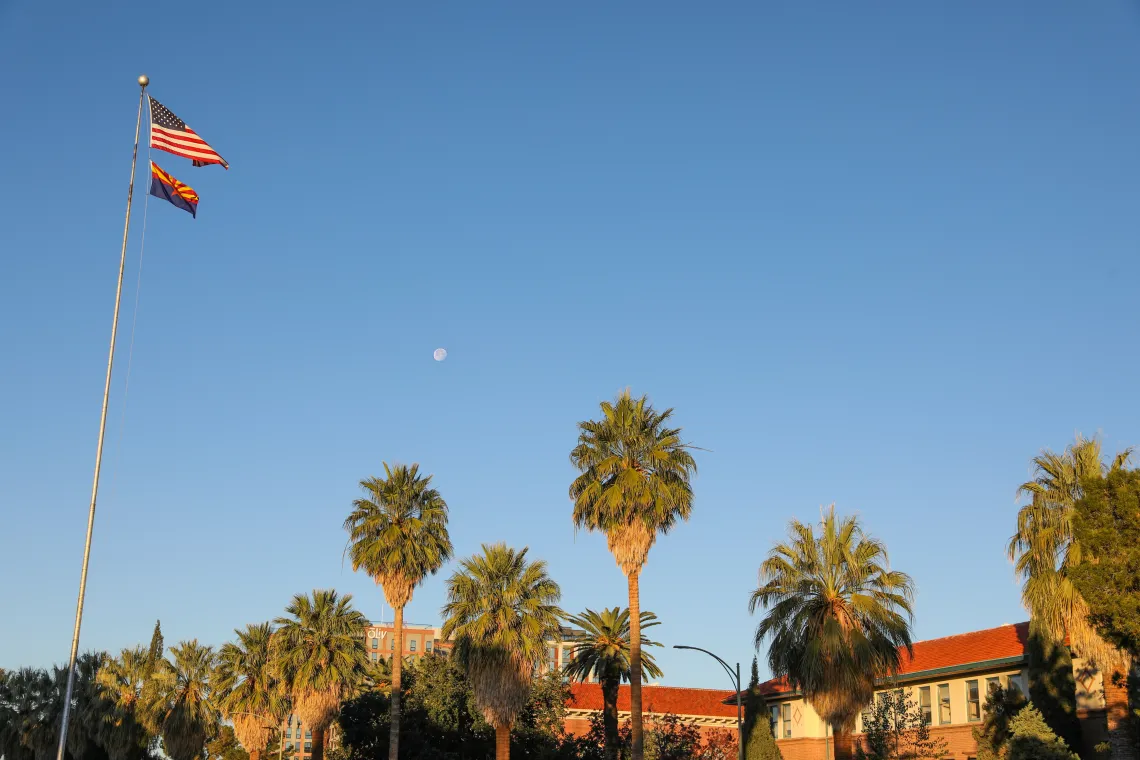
565;623;1127;760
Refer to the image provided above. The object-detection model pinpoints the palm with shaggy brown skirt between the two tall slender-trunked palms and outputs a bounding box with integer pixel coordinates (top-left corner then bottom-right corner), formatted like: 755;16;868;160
442;544;563;760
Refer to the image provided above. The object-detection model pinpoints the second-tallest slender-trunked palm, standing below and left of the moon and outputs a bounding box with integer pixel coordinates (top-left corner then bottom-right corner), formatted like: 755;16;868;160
344;461;451;760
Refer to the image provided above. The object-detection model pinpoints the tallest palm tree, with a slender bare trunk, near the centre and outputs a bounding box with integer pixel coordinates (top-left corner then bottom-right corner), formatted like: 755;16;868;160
570;390;697;760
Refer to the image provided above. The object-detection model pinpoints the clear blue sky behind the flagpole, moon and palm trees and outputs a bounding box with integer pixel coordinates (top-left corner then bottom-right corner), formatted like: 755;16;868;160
0;0;1140;687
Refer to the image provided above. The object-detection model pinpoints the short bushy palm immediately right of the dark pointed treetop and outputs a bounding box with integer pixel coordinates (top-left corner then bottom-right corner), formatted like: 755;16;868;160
152;639;220;760
